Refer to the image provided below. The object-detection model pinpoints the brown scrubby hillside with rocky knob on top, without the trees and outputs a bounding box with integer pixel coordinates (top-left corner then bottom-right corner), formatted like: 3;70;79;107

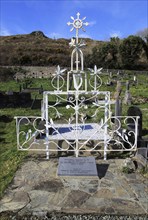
0;31;100;66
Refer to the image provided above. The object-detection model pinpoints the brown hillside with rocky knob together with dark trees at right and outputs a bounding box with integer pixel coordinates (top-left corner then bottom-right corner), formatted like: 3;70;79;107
0;31;148;70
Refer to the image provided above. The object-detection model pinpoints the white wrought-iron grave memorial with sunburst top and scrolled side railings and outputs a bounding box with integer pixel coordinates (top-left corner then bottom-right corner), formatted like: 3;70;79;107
15;13;138;160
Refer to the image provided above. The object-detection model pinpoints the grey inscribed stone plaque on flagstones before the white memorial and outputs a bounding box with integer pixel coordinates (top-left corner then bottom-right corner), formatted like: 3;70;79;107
58;157;98;176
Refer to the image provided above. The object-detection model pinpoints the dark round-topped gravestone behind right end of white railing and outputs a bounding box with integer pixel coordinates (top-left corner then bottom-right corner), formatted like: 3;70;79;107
127;106;142;138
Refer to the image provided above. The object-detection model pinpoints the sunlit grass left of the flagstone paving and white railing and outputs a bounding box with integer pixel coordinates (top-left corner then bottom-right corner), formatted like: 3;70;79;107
0;108;40;197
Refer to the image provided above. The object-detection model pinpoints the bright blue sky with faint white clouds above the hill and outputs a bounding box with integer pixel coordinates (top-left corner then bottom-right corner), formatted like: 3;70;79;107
0;0;148;40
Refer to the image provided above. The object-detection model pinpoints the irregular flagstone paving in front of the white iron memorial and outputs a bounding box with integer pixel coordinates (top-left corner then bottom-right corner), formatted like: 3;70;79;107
0;158;148;216
